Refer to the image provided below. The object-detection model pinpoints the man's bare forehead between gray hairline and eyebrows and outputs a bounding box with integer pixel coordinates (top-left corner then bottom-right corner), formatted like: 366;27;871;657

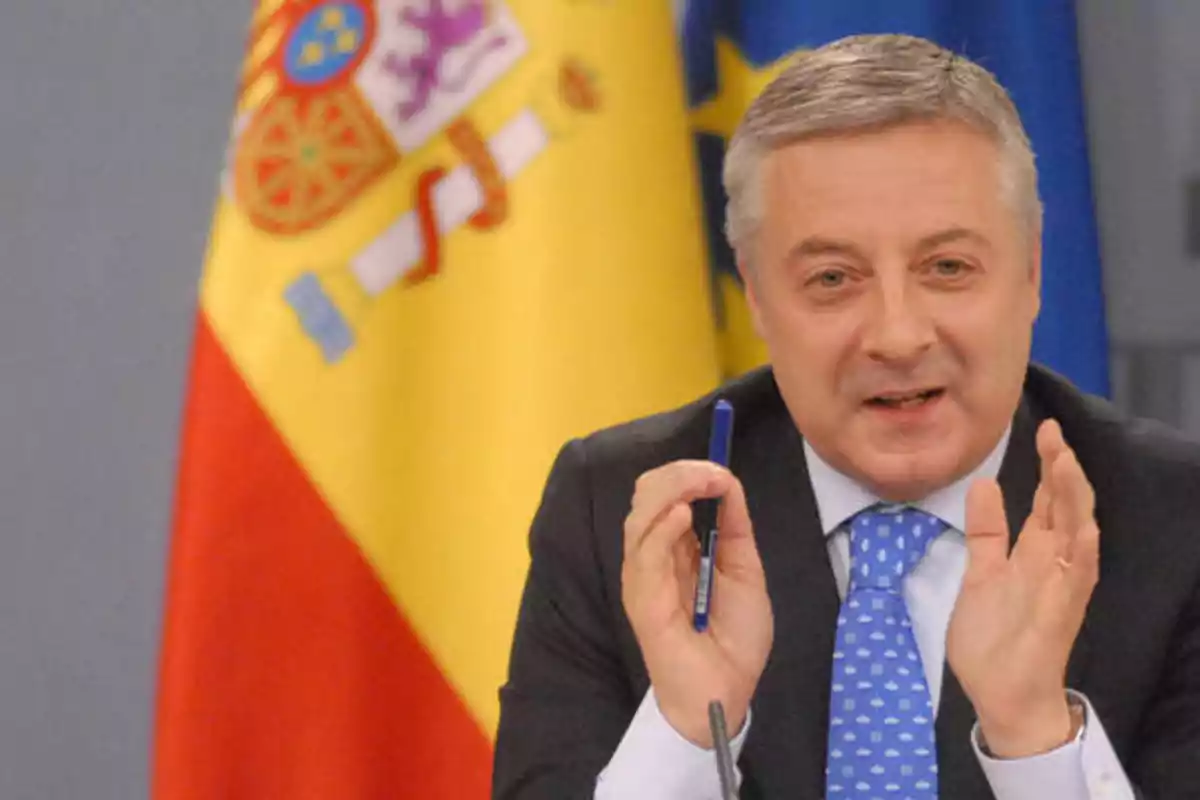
763;120;1016;244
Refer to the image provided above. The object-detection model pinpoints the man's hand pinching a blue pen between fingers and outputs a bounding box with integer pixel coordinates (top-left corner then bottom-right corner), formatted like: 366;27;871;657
622;408;774;747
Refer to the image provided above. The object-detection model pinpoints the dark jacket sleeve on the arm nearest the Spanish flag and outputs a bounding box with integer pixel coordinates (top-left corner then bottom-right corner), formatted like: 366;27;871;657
492;440;640;800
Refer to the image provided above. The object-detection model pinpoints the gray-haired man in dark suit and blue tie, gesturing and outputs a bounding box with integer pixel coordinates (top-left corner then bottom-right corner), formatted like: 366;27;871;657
494;36;1200;800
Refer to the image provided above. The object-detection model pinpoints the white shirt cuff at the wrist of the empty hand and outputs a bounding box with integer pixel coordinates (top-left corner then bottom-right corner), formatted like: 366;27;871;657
971;690;1134;800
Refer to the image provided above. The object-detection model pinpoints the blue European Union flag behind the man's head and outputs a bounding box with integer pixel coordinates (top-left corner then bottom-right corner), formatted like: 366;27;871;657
682;0;1109;396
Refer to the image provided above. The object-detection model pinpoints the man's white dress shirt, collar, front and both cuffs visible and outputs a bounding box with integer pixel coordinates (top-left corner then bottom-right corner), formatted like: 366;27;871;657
594;432;1134;800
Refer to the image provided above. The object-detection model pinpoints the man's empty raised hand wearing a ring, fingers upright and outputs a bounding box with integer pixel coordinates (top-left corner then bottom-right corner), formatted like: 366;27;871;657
947;421;1099;758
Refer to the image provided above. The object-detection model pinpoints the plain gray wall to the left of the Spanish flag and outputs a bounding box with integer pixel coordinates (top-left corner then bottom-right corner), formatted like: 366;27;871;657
0;0;250;800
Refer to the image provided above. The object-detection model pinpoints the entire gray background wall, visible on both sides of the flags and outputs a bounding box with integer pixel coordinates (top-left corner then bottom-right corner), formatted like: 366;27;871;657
0;0;1200;800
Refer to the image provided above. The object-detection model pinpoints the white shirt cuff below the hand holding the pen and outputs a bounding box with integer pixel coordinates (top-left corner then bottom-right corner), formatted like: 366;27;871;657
594;686;750;800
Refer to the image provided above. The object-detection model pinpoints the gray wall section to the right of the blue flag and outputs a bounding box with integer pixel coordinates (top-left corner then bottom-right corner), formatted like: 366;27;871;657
1079;0;1200;433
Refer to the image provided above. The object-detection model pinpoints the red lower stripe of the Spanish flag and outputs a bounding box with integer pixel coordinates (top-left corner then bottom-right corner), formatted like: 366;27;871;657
152;313;491;800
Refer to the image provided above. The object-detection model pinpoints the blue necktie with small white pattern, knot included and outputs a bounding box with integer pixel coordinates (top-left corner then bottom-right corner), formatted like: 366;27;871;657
826;506;946;800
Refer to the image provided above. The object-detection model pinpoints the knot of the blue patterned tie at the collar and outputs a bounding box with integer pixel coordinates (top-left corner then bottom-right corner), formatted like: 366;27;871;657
850;506;947;591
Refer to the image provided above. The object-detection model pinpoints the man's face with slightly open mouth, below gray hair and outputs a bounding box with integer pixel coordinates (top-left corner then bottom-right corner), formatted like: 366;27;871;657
742;121;1040;501
